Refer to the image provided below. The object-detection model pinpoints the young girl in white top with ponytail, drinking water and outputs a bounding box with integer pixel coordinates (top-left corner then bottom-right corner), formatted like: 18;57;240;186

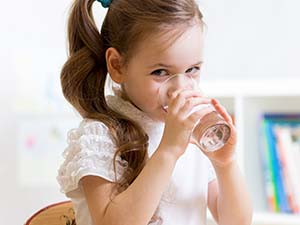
58;0;252;225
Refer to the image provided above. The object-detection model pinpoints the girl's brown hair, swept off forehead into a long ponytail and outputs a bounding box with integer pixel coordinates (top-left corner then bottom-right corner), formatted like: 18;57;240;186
61;0;202;221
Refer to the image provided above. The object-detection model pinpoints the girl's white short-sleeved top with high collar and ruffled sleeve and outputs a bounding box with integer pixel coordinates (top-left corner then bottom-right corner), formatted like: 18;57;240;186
57;96;215;225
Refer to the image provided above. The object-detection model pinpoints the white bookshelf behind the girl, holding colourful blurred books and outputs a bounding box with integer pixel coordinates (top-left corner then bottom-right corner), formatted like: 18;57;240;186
202;78;300;225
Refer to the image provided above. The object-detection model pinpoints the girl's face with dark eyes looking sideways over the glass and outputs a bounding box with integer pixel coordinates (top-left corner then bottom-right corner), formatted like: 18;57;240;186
122;23;203;121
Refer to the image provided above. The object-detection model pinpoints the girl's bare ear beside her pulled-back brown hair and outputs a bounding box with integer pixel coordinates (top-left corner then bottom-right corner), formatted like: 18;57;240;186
105;47;124;84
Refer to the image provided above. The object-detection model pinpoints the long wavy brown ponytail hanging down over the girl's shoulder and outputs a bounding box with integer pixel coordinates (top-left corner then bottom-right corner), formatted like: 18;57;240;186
61;0;148;195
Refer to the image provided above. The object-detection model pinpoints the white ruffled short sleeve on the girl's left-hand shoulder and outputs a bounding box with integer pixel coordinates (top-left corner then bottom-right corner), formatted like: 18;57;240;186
57;120;127;193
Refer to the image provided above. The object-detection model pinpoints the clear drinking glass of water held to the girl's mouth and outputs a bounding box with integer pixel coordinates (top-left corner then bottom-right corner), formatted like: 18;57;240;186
158;74;231;152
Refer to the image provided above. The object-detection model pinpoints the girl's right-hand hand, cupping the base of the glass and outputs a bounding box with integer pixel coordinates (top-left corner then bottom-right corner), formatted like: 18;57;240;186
203;99;237;167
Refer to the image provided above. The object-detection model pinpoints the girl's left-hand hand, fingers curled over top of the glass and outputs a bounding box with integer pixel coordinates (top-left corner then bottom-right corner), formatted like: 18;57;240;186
159;90;211;158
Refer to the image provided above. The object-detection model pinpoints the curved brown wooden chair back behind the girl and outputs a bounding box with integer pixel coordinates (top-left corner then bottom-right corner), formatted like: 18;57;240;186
25;201;76;225
